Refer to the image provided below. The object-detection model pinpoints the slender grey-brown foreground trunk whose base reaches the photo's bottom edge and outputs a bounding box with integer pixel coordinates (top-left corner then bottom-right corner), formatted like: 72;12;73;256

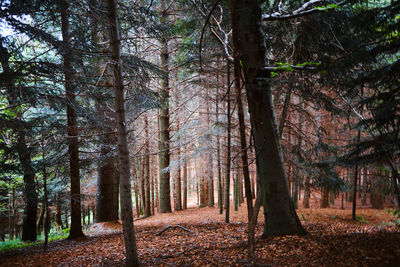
107;0;139;266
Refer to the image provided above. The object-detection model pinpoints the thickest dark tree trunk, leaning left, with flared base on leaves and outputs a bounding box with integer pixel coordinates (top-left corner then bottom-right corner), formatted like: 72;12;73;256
230;0;306;238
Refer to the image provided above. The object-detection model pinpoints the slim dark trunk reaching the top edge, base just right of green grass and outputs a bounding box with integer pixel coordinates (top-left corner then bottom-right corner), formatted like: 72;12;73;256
60;0;84;239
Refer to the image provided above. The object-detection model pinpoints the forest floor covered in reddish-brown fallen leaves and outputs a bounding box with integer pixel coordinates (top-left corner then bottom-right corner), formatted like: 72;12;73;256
0;204;400;266
